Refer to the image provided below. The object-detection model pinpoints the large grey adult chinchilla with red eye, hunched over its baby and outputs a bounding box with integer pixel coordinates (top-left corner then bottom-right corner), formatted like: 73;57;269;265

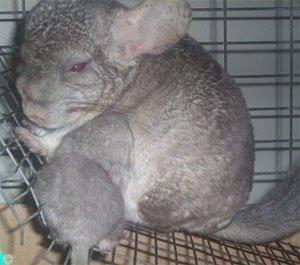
17;0;300;242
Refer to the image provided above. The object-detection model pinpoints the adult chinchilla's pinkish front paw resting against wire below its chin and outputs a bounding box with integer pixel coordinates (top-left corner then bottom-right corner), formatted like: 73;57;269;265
15;126;43;154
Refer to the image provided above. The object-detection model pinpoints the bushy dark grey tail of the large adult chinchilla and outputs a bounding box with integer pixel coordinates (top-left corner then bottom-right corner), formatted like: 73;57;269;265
214;170;300;243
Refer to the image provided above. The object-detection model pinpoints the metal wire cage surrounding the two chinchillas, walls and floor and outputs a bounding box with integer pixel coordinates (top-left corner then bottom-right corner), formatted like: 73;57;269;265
0;0;300;265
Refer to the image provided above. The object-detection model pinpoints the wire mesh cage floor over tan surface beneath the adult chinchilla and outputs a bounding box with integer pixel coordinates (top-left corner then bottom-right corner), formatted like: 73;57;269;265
37;225;300;265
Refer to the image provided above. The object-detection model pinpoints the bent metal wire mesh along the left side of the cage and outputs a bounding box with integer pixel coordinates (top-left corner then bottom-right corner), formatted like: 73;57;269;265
0;45;42;244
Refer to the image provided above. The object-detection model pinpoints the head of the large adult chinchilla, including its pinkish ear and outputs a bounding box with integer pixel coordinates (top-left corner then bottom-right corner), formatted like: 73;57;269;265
16;0;190;129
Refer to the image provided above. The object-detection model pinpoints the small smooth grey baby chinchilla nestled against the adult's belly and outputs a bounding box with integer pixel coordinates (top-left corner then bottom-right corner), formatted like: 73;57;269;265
33;116;132;265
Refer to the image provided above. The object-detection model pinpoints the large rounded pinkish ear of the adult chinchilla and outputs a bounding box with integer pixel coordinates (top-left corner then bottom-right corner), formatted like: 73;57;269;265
111;0;191;60
